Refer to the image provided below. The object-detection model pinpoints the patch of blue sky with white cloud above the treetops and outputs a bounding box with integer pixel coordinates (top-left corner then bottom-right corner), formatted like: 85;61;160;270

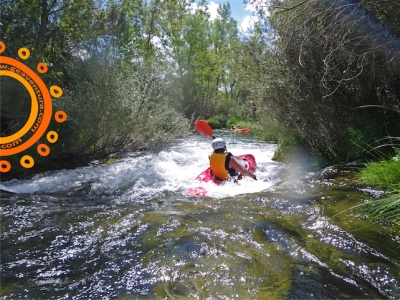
207;0;257;32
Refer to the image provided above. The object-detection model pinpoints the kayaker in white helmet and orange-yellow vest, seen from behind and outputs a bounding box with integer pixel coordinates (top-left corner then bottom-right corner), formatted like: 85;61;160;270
209;138;257;181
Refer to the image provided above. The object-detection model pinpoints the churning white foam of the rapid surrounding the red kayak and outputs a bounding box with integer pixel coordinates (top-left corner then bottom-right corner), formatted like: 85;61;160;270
0;134;281;198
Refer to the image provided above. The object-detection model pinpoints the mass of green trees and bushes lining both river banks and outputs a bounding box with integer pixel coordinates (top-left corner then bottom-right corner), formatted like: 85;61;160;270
0;0;400;230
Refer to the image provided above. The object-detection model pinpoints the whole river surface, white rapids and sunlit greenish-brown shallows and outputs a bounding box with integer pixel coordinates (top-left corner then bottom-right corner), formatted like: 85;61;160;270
0;131;400;299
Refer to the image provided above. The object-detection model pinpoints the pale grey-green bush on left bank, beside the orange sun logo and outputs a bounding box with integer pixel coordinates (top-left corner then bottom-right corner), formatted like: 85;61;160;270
1;51;190;180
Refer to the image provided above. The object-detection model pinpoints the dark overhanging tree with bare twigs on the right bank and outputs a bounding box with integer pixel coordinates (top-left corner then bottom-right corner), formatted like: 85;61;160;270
244;0;400;161
